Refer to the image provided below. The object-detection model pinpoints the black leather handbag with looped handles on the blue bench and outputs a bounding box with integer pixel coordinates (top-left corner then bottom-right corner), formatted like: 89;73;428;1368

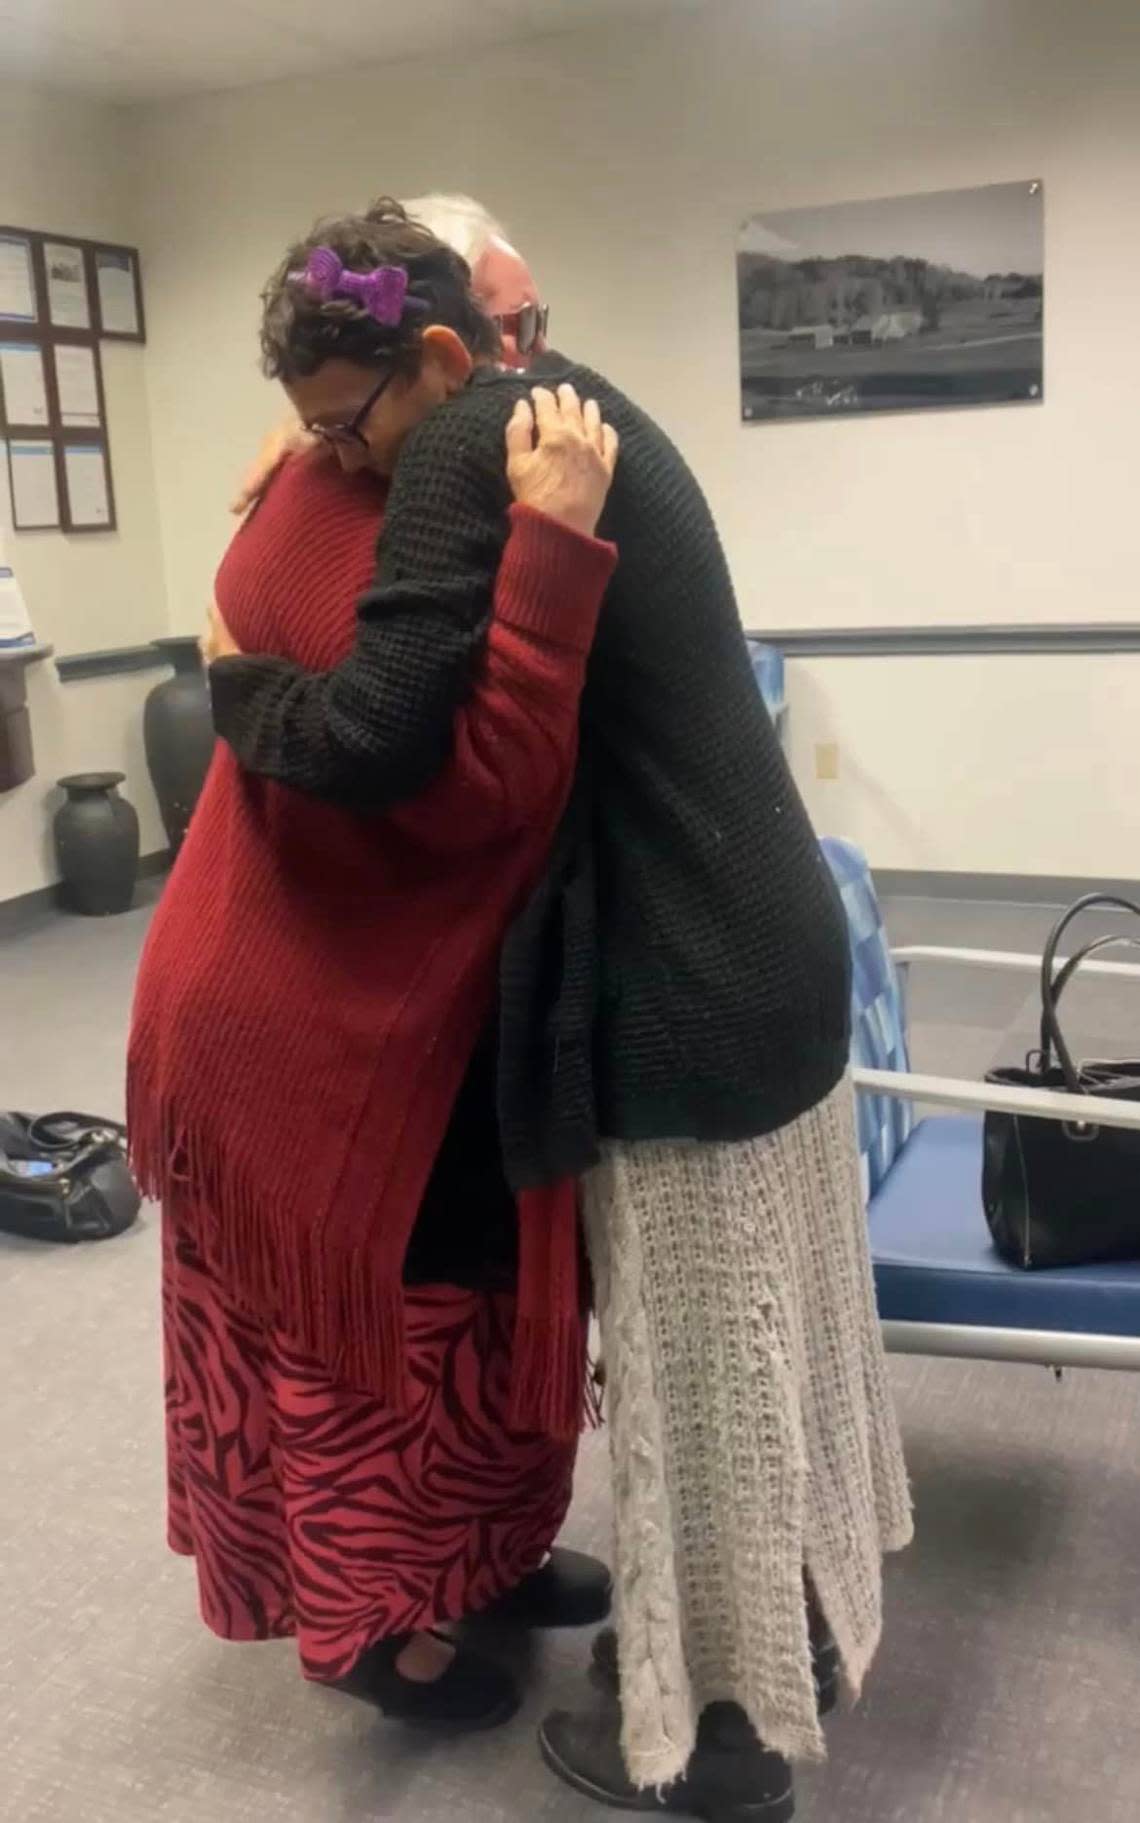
981;893;1140;1271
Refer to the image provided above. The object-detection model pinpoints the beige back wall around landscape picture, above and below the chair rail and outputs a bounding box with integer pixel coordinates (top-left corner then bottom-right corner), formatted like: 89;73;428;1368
128;0;1140;875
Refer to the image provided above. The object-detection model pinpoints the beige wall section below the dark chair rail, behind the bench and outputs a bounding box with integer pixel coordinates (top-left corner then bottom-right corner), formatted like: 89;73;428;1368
788;654;1140;879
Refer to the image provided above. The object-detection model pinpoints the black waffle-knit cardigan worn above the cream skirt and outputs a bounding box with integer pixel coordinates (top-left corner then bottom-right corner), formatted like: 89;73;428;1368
212;355;850;1189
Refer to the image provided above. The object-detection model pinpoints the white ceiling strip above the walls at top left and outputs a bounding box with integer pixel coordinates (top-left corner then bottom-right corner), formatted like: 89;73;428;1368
0;0;693;102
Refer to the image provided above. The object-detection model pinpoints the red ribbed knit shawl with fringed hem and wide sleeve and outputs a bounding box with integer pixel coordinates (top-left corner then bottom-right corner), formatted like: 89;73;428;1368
130;461;613;1429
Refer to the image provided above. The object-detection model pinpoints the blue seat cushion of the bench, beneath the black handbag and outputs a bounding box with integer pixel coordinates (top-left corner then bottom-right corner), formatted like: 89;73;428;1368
868;1114;1140;1336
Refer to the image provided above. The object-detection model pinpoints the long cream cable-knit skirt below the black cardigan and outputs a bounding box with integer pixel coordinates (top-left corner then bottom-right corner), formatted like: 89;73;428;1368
584;1081;912;1787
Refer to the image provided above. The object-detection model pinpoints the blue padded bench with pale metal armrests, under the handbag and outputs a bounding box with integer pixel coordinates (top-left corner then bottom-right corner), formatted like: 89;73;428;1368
823;840;1140;1371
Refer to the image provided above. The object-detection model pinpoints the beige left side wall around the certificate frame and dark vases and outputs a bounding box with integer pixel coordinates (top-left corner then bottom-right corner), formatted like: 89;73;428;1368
0;84;166;901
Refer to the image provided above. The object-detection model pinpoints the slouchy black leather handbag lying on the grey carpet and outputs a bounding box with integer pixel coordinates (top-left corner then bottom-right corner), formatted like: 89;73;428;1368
0;1114;140;1241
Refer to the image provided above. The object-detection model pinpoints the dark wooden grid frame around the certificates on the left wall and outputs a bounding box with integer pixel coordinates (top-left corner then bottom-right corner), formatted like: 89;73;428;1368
0;224;146;534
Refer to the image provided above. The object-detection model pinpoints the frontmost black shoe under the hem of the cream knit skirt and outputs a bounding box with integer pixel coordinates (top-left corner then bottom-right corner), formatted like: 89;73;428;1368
538;1703;795;1823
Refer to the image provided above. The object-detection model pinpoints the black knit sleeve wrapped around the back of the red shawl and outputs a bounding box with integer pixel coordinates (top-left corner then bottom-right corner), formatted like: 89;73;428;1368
210;392;514;811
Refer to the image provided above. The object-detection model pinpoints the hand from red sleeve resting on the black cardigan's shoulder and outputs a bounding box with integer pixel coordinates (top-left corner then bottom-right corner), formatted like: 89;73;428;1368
507;386;618;538
